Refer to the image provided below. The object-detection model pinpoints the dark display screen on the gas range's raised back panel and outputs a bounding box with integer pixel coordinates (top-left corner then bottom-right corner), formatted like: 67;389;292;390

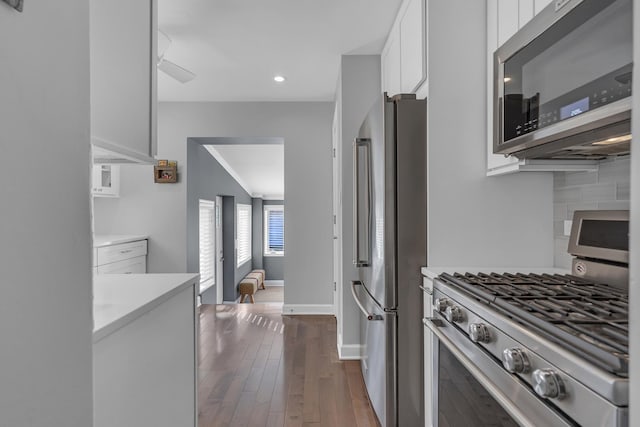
578;219;629;251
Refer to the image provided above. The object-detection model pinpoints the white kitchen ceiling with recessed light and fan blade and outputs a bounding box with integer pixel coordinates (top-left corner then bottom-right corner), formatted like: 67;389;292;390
158;0;401;101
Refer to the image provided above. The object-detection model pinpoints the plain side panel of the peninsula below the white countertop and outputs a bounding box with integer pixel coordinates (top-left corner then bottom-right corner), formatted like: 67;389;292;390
93;286;197;427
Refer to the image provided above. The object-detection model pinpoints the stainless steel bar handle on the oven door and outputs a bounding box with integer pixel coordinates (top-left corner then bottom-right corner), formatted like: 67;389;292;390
422;317;536;427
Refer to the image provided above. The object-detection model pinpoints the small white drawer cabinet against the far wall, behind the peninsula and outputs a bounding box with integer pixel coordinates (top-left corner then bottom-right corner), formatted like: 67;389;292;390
93;239;147;274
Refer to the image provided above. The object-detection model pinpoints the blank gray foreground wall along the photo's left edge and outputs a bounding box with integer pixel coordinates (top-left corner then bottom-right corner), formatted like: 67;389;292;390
0;0;93;427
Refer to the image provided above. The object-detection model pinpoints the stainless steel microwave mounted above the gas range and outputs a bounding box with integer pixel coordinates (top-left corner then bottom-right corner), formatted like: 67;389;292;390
493;0;633;159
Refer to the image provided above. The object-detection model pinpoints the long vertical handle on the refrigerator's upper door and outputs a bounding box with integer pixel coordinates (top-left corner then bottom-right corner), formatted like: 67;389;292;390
353;138;372;267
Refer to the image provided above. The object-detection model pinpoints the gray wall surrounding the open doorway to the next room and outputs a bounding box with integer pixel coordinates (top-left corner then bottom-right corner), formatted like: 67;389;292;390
96;102;333;305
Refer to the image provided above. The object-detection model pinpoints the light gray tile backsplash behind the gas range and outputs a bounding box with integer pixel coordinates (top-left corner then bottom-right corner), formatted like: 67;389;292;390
553;157;631;268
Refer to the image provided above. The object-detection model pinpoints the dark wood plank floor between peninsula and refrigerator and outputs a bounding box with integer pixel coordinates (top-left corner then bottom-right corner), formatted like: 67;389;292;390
198;304;379;427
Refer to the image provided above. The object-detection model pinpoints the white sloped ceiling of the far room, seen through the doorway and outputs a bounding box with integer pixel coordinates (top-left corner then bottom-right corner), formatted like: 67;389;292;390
204;144;284;200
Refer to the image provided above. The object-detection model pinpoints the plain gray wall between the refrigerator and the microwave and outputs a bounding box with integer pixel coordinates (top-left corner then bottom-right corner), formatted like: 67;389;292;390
427;0;553;268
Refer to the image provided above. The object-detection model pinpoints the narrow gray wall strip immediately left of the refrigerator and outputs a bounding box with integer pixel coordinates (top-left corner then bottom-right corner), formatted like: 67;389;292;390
338;55;381;346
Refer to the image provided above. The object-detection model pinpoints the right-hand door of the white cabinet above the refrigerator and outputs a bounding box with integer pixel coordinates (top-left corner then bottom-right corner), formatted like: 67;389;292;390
400;0;426;93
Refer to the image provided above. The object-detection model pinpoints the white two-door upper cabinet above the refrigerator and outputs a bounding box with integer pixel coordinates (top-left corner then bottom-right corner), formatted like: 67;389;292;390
381;0;427;96
